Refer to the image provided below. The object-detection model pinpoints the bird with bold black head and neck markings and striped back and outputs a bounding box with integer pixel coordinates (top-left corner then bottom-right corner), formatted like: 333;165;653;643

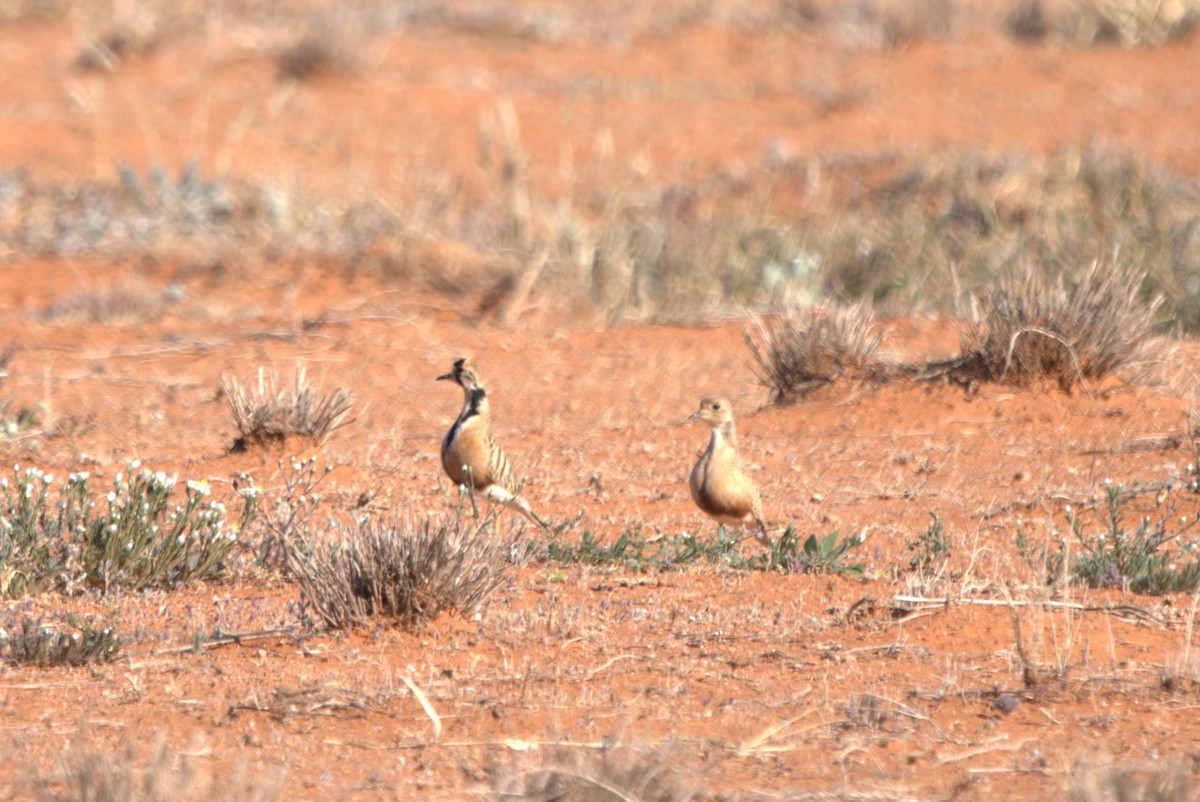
437;357;550;529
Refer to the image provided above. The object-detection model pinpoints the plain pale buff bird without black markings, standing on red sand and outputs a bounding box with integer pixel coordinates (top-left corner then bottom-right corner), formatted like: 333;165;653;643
688;396;770;549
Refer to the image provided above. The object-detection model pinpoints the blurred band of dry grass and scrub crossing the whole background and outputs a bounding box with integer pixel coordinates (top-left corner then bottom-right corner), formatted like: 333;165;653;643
0;147;1200;328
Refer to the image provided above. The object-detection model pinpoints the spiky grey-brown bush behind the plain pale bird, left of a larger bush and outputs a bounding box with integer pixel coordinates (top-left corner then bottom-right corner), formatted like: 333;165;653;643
742;304;883;403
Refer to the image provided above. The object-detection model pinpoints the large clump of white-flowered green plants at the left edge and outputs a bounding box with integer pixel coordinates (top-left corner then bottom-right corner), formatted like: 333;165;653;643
0;461;258;595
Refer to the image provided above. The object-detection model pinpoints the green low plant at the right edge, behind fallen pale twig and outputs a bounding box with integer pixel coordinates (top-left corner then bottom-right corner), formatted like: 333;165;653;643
1016;483;1200;593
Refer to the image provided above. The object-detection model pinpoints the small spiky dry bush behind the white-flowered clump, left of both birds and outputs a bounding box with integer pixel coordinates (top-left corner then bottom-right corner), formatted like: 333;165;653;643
221;367;354;449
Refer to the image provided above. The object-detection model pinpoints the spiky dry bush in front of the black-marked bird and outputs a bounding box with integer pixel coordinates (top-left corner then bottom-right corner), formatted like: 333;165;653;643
286;510;510;629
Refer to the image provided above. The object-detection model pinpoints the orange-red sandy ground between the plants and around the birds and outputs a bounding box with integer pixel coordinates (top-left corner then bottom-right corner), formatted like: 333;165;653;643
0;7;1200;800
